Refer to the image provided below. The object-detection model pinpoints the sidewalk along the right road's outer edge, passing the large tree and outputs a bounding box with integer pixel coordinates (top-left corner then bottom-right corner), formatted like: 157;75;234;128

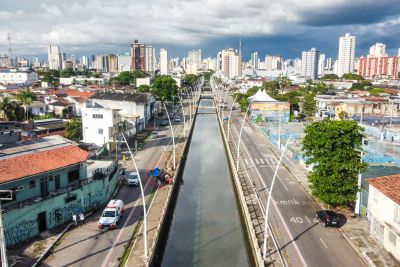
249;122;399;267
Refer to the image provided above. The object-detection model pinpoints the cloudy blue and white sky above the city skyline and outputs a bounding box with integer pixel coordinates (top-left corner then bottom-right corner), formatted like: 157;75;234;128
0;0;400;60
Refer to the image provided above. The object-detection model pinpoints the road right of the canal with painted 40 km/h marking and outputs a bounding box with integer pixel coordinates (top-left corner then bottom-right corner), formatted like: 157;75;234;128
225;96;365;266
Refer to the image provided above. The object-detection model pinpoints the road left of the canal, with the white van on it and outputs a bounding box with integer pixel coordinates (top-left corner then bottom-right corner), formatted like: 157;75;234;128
43;100;189;267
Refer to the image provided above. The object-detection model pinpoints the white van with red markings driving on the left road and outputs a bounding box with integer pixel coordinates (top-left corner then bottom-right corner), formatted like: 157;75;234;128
99;199;124;229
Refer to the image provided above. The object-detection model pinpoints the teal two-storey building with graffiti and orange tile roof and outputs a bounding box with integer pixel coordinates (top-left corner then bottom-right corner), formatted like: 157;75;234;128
0;136;117;246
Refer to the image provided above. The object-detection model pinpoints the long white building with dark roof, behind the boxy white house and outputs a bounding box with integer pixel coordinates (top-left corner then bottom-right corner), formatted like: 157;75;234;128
91;92;156;131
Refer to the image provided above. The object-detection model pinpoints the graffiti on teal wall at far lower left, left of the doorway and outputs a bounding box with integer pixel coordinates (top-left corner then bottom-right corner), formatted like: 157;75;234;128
4;220;37;246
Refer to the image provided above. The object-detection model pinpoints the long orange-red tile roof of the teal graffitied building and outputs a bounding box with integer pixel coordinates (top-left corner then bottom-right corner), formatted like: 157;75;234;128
0;145;88;184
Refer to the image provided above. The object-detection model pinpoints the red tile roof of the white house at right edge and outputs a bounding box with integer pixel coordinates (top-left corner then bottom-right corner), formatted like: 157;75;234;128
367;174;400;205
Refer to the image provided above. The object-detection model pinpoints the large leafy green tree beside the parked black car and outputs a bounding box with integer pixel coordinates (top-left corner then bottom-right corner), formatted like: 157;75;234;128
302;120;367;207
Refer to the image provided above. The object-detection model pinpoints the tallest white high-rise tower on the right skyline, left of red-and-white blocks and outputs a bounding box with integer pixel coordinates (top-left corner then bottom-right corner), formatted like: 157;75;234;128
337;33;356;77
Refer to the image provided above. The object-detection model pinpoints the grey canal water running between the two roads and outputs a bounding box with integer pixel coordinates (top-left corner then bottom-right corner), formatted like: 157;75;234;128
161;99;250;267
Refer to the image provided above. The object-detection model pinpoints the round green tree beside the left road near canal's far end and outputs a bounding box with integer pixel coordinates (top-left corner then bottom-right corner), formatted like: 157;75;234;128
151;75;178;102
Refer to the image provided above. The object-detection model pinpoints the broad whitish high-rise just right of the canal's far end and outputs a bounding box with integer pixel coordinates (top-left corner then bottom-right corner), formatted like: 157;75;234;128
217;48;242;78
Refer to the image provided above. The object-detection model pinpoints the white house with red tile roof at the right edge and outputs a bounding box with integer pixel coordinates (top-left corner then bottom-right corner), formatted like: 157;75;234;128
367;174;400;261
